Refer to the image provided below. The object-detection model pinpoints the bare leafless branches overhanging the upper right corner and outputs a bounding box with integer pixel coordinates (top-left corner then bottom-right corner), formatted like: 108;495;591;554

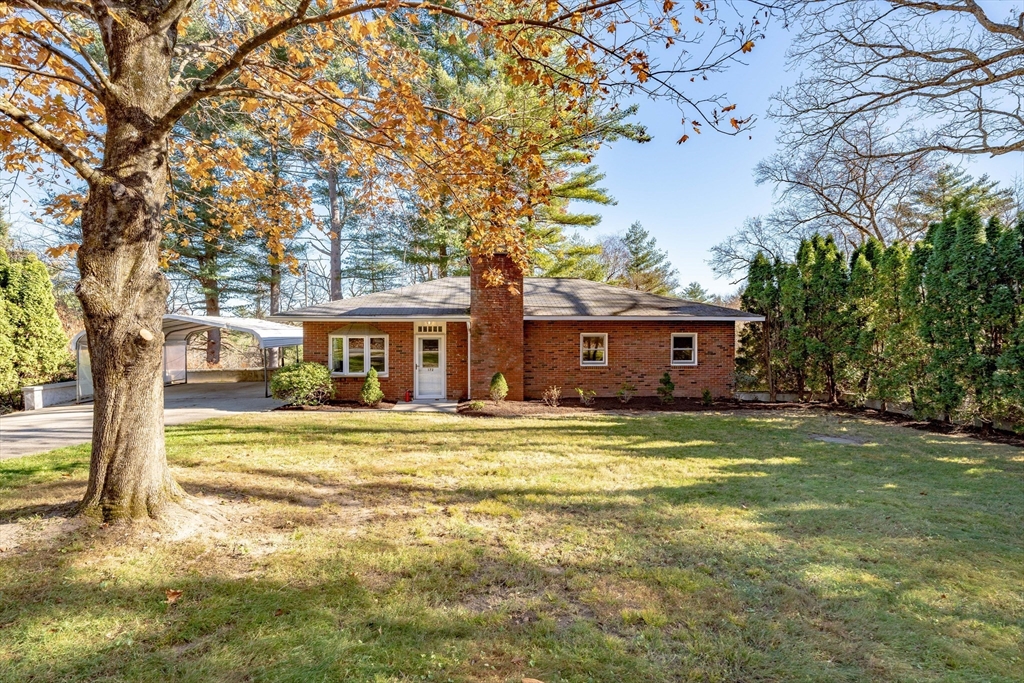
773;0;1024;156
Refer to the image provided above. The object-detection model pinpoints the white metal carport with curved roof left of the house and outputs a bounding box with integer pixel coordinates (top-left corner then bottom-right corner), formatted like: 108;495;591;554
71;313;302;400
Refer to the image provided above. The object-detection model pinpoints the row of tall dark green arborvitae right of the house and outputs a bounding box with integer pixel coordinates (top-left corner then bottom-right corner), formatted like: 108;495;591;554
737;207;1024;423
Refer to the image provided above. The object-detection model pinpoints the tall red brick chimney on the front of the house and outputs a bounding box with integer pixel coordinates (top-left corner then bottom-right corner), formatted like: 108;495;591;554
469;254;523;400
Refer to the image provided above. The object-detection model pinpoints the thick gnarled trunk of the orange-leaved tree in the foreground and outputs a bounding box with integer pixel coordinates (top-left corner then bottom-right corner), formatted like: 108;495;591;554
78;12;184;521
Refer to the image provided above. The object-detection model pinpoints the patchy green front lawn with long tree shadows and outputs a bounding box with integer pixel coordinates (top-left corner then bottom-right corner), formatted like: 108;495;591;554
0;413;1024;683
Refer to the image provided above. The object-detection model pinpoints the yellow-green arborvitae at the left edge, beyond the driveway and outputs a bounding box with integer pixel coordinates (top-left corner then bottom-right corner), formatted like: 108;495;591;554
0;253;71;386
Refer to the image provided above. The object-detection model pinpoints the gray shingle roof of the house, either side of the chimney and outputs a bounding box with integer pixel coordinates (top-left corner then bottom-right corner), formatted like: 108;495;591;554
273;278;761;321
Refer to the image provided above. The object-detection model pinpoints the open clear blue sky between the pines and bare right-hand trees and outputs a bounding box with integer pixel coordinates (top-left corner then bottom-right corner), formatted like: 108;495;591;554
588;26;1024;294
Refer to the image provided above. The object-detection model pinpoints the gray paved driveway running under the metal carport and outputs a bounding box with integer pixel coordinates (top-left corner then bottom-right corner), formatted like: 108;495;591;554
0;382;284;460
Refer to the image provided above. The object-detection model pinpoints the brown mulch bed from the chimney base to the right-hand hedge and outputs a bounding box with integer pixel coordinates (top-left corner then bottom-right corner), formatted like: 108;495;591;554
459;396;1024;447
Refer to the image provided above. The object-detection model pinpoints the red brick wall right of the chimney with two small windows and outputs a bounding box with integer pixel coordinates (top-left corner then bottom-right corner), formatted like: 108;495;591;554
524;321;735;398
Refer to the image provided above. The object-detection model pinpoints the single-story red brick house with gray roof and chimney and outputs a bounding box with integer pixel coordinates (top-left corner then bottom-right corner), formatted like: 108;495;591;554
273;254;763;400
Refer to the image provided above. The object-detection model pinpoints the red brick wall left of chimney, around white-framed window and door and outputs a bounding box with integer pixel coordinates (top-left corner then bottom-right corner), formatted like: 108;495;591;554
302;321;467;400
